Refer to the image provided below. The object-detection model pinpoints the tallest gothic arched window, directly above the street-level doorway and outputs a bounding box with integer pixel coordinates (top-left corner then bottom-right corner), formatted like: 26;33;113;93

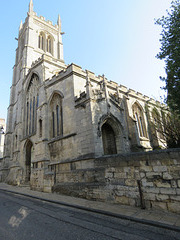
24;74;39;136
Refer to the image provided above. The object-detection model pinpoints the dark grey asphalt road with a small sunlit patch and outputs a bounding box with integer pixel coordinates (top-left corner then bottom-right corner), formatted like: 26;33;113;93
0;192;180;240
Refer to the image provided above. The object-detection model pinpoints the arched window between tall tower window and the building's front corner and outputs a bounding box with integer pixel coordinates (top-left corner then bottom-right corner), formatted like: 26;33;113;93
50;93;63;138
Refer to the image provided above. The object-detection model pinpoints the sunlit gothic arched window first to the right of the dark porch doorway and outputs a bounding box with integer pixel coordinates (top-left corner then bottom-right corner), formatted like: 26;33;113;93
132;103;147;137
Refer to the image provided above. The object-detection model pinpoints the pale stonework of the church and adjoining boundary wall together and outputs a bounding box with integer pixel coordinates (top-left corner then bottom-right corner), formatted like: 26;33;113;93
0;0;177;215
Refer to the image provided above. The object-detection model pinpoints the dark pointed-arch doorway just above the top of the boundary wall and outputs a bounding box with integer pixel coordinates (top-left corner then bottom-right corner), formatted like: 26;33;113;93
101;122;117;155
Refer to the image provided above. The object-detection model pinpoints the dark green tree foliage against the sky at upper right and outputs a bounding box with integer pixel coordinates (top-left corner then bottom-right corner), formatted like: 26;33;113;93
156;0;180;118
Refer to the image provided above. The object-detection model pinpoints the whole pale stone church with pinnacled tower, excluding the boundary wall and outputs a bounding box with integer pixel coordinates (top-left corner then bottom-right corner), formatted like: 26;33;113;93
0;0;164;190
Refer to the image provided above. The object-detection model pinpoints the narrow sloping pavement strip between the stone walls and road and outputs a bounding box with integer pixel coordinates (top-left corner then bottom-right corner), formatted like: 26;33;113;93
0;183;180;232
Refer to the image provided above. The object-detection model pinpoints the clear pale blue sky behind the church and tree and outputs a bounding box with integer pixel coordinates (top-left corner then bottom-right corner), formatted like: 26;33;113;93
0;0;171;118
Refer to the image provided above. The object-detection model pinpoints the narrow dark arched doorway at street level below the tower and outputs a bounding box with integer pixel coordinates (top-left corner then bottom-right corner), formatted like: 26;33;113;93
26;140;33;182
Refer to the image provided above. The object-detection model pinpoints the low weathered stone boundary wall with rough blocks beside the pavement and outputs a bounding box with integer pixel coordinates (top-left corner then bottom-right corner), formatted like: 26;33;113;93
51;149;180;213
